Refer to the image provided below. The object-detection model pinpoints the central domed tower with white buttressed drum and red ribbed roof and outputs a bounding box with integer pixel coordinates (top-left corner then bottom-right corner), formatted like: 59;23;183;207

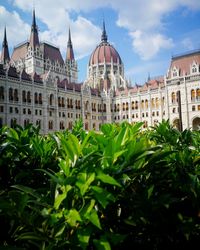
86;21;126;91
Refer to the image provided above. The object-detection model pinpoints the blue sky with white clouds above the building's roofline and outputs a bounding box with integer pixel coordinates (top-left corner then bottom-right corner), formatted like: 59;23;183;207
0;0;200;85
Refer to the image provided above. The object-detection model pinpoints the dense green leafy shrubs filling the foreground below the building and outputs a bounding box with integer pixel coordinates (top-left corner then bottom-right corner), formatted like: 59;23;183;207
0;121;200;250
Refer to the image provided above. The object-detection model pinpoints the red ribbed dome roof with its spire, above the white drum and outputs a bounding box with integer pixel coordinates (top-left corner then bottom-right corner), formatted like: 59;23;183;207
89;22;122;66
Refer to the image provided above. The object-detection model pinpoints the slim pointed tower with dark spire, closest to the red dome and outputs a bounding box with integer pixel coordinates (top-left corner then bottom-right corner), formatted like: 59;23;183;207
65;28;78;82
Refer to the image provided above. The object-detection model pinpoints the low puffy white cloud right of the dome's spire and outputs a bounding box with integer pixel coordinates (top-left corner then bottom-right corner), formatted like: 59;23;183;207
130;30;173;60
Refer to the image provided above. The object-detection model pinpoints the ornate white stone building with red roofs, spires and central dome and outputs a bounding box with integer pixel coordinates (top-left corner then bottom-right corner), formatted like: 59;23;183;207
0;11;200;134
